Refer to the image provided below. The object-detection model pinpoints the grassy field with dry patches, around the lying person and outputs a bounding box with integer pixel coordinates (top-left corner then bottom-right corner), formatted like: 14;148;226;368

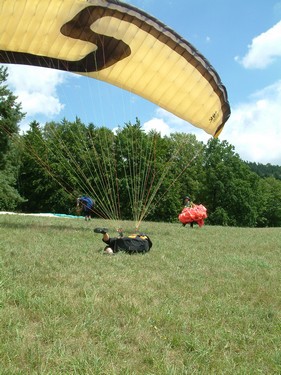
0;215;281;375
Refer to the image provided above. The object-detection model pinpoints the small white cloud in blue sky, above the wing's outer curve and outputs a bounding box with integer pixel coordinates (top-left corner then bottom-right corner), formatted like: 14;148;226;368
235;21;281;69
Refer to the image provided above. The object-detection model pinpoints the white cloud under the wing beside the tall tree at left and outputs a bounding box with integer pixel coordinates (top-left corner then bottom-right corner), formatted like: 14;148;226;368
7;65;67;119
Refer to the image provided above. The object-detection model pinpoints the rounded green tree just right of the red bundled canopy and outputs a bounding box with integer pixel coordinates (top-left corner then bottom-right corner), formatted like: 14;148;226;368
204;139;259;227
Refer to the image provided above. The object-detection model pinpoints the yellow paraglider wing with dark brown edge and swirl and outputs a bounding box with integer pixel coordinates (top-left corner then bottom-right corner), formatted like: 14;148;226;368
0;0;230;137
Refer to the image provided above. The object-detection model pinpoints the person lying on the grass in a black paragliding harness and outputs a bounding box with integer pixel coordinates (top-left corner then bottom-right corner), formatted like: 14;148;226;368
94;228;152;255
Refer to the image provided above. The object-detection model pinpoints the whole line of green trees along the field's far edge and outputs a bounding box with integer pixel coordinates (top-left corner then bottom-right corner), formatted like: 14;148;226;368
0;67;281;227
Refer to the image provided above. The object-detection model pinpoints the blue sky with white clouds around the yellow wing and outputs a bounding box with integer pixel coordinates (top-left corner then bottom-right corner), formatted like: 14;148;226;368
3;0;281;166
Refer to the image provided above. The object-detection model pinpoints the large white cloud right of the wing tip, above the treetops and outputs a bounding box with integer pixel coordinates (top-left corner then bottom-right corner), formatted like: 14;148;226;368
220;80;281;165
